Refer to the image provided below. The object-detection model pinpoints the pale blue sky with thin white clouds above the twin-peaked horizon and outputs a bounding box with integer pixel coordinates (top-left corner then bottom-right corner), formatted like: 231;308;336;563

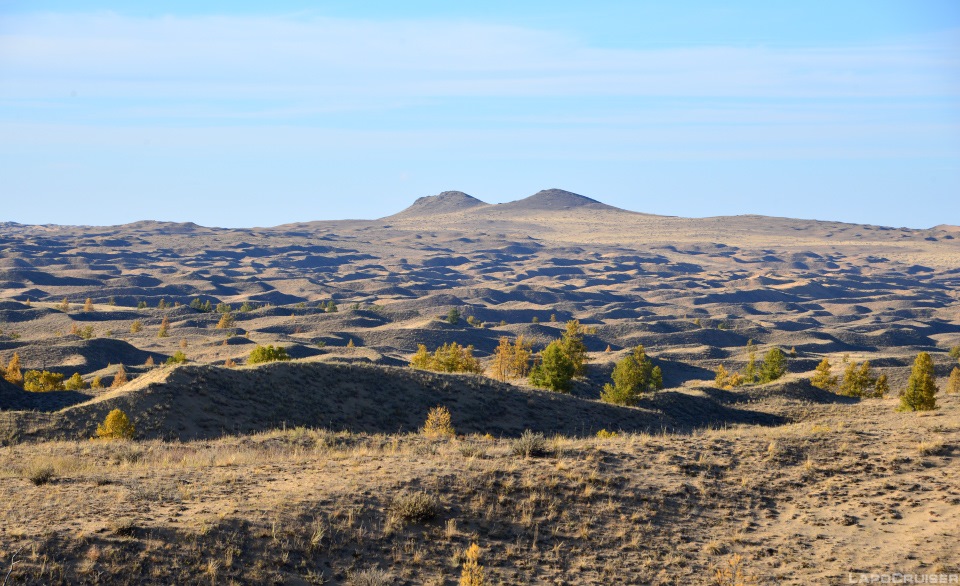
0;0;960;228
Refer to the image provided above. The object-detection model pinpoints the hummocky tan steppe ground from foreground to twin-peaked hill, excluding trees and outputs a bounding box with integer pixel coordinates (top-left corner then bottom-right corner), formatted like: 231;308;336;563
0;189;960;584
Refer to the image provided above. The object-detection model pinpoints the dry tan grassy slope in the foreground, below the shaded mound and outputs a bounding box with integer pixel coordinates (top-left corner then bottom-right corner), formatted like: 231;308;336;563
0;392;960;584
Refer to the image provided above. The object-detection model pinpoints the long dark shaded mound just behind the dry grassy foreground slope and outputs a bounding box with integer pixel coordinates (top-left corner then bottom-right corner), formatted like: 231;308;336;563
6;362;782;440
